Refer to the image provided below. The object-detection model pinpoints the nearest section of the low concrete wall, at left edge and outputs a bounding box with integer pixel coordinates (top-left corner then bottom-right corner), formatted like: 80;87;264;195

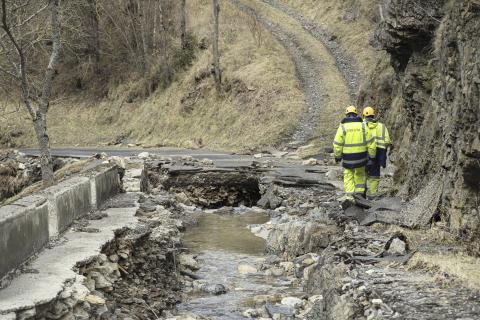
0;196;49;278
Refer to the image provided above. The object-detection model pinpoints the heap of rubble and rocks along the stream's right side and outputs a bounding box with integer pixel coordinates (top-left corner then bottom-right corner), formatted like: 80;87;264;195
249;175;480;320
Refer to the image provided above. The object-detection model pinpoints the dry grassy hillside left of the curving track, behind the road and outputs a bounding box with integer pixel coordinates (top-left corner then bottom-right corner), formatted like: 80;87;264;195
0;0;304;150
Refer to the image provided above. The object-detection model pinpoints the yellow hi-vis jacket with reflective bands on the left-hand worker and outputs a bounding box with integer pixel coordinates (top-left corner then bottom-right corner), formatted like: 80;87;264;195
333;117;377;169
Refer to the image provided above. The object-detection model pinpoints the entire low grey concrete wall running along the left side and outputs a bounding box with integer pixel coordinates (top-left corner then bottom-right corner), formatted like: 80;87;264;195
0;167;121;279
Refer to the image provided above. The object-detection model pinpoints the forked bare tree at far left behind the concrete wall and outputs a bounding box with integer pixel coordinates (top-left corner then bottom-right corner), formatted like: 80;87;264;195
0;0;61;186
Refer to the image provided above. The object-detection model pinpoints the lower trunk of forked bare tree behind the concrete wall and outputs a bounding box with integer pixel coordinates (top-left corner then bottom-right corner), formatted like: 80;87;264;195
33;115;55;187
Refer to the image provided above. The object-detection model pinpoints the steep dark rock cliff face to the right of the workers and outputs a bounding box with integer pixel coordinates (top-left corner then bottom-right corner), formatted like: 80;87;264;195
358;0;480;230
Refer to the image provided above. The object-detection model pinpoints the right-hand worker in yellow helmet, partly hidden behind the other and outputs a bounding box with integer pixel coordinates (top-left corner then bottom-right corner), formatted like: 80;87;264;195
363;107;391;198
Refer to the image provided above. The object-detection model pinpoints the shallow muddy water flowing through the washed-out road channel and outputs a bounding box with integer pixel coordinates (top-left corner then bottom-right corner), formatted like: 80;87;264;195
178;212;297;319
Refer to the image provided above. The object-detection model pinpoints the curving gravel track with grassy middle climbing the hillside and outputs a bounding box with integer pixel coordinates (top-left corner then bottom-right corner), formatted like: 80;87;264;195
230;0;352;147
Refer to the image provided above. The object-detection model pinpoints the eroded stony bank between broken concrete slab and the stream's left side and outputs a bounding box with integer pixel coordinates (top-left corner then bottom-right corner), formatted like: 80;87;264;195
78;197;184;319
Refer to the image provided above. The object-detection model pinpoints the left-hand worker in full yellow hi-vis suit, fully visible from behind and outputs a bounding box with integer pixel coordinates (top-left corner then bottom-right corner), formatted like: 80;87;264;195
333;106;377;199
